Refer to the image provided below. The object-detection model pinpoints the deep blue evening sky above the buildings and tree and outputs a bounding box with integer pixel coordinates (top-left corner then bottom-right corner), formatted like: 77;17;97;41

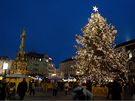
0;0;135;66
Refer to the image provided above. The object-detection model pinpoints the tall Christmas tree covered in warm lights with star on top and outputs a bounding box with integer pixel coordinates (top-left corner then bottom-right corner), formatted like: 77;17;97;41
74;6;128;81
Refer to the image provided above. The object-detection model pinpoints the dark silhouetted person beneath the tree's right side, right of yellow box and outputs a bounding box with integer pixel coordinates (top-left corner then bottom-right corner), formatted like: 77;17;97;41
111;80;122;100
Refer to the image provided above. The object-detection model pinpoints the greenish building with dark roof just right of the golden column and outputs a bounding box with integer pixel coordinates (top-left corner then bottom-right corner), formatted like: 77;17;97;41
25;52;55;77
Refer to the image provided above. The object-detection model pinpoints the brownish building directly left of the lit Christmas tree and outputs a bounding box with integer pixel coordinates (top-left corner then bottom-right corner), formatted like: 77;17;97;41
59;58;76;77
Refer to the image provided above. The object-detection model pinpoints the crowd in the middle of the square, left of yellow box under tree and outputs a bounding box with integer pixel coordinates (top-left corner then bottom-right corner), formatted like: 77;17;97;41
41;79;93;100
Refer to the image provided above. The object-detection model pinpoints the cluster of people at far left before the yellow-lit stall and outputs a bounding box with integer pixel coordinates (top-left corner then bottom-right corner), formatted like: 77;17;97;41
0;78;35;100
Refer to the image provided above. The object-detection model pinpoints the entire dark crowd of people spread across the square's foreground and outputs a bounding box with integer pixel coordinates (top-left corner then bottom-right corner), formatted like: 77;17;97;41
0;78;135;100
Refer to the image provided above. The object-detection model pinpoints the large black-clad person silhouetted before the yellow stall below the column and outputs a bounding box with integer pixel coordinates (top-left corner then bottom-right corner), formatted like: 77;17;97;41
17;78;27;100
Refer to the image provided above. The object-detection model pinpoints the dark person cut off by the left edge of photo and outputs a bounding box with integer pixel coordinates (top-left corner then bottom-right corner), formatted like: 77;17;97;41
0;78;7;100
